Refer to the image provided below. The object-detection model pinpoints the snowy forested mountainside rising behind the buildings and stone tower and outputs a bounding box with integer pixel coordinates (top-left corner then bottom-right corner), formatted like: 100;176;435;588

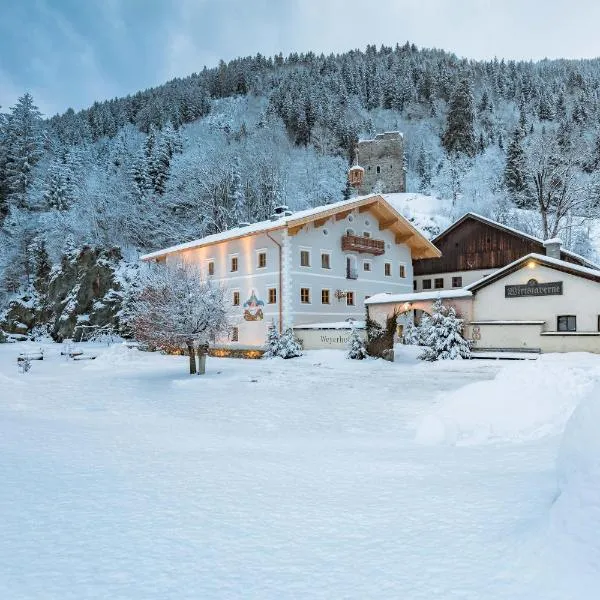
0;43;600;330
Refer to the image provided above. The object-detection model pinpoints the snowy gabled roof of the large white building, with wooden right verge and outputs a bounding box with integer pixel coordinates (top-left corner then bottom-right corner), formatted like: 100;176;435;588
140;194;439;260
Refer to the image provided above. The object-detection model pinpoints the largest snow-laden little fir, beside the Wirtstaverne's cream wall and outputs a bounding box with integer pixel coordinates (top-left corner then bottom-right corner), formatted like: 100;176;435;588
419;299;471;361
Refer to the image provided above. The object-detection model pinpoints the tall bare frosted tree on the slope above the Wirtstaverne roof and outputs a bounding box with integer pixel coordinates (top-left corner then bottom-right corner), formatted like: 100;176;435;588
527;133;599;239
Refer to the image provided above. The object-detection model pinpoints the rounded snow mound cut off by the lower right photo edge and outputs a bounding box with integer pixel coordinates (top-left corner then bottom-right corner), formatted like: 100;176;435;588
552;383;600;572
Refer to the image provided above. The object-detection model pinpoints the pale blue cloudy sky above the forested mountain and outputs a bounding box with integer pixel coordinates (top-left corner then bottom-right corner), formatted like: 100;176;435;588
0;0;600;114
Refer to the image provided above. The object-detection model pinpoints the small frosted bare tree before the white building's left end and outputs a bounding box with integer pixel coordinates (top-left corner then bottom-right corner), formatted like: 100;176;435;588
126;262;230;374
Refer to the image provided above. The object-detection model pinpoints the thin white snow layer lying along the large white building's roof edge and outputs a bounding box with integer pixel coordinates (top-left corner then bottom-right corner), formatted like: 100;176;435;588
140;194;428;260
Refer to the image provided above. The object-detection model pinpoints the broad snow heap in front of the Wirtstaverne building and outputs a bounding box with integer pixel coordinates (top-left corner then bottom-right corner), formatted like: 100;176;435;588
416;354;599;444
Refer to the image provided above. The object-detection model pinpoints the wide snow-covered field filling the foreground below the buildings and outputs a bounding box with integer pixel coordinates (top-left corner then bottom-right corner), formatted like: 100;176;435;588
0;344;600;600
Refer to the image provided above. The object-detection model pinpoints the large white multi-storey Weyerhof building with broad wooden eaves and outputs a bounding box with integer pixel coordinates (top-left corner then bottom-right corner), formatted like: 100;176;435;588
142;196;439;347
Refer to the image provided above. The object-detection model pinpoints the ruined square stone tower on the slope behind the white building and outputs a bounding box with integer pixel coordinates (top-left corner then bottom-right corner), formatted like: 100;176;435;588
356;131;406;195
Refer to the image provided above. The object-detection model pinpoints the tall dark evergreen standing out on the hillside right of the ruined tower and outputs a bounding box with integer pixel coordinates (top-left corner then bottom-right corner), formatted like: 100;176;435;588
442;78;477;157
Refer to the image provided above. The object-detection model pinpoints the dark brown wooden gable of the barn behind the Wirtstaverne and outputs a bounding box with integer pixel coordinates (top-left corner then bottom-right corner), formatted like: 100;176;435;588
413;215;581;275
